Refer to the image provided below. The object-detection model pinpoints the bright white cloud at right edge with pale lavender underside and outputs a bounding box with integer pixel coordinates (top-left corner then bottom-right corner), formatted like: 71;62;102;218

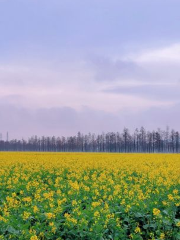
124;43;180;84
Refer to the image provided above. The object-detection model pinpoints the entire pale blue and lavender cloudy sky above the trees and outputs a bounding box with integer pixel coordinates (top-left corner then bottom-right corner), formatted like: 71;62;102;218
0;0;180;139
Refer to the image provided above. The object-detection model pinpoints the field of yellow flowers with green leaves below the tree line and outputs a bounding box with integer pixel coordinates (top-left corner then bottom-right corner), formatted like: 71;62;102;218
0;153;180;240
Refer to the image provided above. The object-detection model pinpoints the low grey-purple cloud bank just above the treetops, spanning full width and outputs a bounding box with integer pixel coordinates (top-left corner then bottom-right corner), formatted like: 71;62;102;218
0;103;180;139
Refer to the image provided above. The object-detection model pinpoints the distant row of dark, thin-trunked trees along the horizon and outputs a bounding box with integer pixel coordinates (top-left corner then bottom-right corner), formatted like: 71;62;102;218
0;127;180;153
